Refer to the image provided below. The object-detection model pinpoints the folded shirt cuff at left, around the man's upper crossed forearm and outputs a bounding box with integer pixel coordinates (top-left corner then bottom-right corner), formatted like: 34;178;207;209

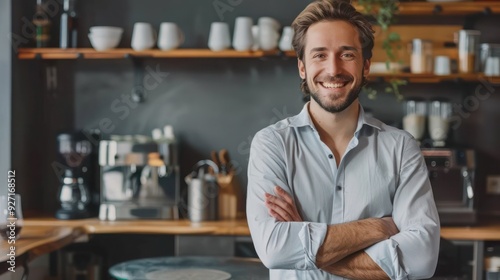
296;222;327;270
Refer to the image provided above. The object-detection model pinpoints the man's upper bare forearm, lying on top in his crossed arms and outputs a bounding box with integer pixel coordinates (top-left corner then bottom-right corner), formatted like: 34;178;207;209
316;218;397;268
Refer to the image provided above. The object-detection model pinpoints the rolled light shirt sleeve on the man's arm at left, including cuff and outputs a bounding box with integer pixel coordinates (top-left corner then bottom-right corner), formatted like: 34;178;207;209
247;129;327;270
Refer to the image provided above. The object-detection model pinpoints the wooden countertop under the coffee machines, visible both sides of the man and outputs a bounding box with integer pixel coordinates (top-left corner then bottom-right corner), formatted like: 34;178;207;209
0;218;500;274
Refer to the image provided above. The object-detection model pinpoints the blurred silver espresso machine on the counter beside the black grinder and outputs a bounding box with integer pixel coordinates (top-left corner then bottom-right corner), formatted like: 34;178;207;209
99;128;180;220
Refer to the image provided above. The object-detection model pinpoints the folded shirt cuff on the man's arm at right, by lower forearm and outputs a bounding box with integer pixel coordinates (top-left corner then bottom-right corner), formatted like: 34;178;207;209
365;239;409;280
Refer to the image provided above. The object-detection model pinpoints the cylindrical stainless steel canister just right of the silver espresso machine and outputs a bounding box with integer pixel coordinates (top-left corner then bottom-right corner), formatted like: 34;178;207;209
185;160;219;222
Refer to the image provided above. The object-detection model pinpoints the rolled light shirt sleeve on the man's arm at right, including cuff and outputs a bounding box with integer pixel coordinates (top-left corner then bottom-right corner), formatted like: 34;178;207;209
365;138;440;279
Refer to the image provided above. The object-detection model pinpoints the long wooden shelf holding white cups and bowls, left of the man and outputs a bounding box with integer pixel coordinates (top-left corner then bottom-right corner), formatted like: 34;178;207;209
17;48;278;59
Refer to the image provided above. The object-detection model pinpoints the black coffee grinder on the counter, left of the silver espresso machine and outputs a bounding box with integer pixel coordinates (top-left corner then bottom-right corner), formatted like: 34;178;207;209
55;132;99;220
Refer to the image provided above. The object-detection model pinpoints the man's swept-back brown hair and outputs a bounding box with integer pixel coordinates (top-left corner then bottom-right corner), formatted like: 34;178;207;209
292;0;374;94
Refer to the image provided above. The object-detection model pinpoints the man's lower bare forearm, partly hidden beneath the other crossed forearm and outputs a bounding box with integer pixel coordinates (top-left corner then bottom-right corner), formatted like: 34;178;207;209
323;251;389;280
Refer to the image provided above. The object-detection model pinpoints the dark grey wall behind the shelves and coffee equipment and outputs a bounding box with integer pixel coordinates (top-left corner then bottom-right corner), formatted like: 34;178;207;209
9;0;500;215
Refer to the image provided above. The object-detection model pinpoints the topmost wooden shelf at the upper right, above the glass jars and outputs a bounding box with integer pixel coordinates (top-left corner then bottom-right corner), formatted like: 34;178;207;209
355;1;500;15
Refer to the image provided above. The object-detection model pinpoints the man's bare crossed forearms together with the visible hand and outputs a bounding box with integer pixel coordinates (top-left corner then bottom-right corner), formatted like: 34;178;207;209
265;187;399;279
